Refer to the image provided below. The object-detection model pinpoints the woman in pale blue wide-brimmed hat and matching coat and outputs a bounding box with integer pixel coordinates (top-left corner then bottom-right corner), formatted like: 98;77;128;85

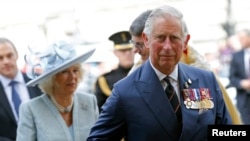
17;42;99;141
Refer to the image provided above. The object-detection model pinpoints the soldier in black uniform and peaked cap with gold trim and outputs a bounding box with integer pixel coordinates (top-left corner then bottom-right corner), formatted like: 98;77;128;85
95;31;134;111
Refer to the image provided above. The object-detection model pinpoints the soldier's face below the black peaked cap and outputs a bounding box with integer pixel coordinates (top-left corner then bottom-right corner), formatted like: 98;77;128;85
114;48;135;68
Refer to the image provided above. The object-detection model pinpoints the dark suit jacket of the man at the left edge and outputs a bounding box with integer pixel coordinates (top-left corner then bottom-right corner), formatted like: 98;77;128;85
0;74;42;141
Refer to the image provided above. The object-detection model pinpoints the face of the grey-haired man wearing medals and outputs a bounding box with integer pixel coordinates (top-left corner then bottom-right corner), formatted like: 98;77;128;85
143;16;189;74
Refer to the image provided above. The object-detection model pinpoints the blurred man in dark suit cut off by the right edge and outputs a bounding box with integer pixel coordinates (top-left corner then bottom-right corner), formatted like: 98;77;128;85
229;29;250;124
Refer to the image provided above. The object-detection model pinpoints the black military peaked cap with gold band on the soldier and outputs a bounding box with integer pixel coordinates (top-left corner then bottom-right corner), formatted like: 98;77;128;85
109;31;133;50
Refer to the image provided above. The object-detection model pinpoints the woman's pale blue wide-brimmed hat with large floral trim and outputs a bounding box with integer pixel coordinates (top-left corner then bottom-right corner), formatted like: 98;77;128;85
25;41;95;86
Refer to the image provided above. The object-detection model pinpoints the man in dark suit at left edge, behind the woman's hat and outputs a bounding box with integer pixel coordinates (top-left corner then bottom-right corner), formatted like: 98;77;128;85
0;38;42;141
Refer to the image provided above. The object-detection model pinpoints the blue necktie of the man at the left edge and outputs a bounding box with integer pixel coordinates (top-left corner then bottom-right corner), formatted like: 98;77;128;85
9;80;21;116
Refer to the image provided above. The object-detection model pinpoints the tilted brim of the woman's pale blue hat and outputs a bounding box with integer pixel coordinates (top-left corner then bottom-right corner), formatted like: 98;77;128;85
26;48;95;86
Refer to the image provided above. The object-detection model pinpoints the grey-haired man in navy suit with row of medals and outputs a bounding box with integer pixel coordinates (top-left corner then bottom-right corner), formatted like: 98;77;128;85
87;5;232;141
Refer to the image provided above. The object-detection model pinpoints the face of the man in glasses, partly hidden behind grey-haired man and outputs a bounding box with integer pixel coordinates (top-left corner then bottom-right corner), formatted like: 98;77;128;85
131;36;149;62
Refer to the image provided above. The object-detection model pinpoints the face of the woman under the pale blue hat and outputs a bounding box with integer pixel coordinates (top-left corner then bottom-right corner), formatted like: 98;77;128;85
54;65;81;94
